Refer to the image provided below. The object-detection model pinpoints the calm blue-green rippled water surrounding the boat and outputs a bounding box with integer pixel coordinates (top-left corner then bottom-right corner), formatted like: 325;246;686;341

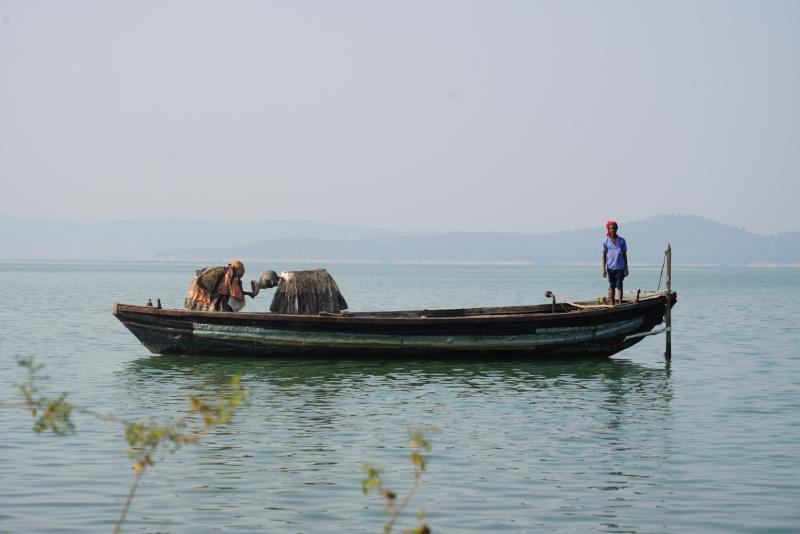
0;262;800;533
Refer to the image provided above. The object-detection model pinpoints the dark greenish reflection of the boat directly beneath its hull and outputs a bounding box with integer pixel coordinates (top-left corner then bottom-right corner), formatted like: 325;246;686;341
128;355;671;402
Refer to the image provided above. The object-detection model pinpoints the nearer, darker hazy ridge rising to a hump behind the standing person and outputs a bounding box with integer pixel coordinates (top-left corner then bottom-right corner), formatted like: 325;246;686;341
160;215;800;265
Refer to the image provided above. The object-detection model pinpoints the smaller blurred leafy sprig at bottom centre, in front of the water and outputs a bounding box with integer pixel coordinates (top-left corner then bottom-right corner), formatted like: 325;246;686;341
361;428;436;534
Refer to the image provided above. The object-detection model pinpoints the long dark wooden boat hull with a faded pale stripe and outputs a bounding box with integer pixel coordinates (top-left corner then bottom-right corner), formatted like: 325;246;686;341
114;292;677;358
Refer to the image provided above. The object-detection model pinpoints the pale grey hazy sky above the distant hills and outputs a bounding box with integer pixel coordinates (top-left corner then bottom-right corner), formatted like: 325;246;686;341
0;0;800;232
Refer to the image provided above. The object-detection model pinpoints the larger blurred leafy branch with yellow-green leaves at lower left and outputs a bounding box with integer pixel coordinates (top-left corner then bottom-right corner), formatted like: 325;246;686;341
11;359;247;533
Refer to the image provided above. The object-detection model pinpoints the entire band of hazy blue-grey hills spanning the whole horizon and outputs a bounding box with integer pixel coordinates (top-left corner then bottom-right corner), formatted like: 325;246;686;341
0;215;800;265
